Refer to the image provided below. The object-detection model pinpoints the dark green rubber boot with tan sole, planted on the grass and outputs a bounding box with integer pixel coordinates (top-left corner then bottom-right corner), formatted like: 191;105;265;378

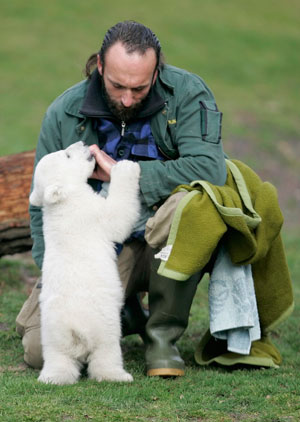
146;259;201;377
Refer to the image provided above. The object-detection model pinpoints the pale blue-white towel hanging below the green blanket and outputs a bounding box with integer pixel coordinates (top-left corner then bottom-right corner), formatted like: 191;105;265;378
209;246;261;355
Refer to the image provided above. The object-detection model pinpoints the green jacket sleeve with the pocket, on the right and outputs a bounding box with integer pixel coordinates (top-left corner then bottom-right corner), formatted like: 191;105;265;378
139;76;226;206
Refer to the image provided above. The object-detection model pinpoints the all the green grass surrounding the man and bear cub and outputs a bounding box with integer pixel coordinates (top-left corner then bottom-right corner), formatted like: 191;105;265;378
0;0;300;422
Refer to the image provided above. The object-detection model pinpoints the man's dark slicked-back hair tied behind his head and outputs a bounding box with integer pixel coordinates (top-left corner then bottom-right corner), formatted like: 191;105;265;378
85;21;164;78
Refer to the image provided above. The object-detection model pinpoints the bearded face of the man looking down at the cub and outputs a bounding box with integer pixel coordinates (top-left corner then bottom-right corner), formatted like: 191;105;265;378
97;43;157;121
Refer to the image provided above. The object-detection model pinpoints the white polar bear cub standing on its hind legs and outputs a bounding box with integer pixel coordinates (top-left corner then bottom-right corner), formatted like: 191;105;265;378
30;142;140;384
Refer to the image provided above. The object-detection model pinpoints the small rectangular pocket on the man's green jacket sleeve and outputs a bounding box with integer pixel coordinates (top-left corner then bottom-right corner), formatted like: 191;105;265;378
200;101;222;144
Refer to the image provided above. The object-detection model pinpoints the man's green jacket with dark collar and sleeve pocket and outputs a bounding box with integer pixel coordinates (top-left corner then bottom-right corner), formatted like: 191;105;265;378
30;65;226;267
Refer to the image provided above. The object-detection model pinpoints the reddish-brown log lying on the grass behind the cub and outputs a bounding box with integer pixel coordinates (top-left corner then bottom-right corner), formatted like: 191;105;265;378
0;150;35;257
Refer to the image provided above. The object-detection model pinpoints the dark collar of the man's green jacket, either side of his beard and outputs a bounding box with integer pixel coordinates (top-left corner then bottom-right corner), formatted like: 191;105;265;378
80;69;165;118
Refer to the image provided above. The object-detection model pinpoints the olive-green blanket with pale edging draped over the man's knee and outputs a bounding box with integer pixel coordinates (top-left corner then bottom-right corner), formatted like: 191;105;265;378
158;160;293;367
